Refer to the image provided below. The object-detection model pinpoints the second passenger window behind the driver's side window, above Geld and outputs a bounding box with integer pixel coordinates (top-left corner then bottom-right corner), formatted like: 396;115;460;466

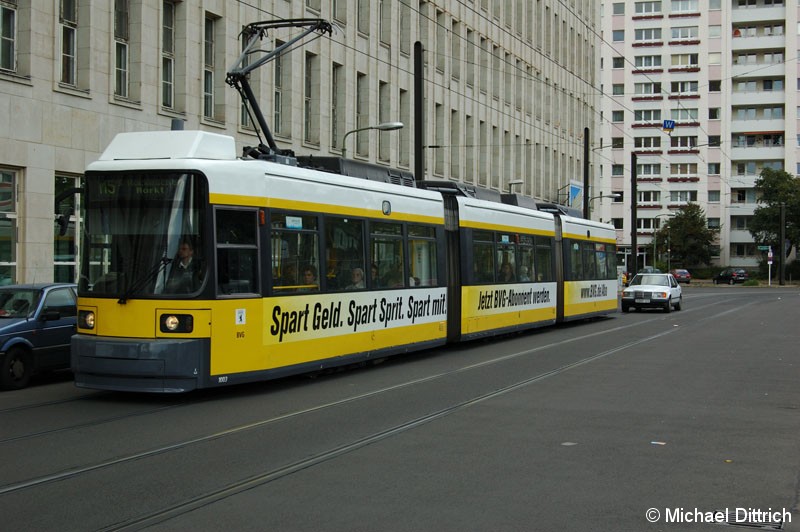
325;217;366;290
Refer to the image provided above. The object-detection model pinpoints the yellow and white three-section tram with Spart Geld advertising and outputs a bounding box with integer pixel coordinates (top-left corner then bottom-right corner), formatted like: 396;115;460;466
72;131;617;392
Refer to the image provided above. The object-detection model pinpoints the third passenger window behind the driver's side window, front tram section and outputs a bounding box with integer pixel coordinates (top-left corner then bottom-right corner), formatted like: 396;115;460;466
369;222;406;288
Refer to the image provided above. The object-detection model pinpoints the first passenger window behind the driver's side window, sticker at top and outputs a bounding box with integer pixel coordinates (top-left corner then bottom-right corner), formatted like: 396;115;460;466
270;212;320;294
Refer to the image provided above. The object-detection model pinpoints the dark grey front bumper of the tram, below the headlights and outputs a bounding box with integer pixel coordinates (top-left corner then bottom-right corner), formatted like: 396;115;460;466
71;334;210;393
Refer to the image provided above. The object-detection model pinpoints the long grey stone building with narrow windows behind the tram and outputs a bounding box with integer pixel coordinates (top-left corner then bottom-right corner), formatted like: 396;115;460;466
0;0;599;283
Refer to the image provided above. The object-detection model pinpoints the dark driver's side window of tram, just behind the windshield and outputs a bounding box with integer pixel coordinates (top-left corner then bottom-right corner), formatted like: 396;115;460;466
216;209;260;295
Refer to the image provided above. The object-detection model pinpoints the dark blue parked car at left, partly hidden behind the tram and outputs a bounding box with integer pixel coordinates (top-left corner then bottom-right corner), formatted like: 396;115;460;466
0;283;78;389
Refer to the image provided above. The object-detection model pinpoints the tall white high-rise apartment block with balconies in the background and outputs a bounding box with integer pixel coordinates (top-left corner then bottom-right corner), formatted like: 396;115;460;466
595;0;800;268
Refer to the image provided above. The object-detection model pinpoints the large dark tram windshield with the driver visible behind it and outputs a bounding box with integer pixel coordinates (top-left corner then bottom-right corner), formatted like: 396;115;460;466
78;172;209;302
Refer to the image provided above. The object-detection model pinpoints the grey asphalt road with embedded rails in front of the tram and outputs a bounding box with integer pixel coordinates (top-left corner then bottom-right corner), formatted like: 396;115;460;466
0;286;800;532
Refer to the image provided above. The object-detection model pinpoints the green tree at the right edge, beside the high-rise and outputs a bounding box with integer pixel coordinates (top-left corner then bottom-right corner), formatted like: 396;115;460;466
748;168;800;255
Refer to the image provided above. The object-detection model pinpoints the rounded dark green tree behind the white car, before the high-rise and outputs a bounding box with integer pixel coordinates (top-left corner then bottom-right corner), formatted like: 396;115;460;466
654;203;719;267
